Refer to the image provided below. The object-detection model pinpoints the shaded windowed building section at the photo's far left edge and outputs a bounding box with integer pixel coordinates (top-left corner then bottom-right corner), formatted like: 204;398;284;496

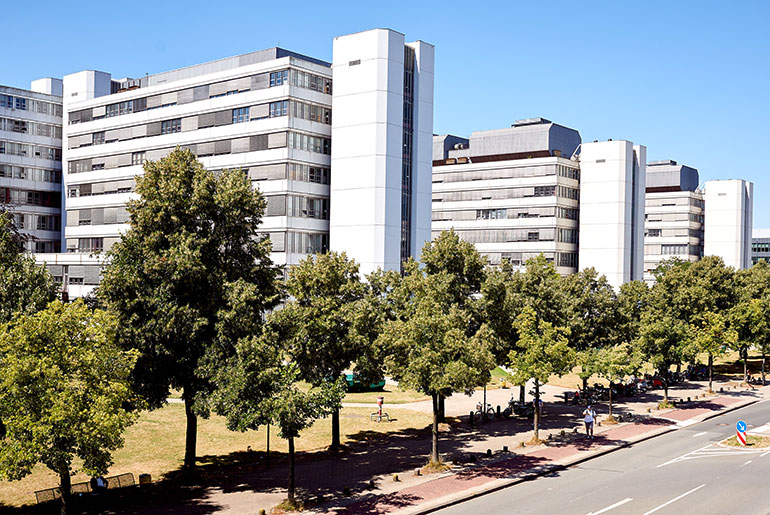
0;78;62;253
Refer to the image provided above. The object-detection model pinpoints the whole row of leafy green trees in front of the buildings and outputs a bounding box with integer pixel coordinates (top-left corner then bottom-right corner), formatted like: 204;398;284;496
0;150;770;512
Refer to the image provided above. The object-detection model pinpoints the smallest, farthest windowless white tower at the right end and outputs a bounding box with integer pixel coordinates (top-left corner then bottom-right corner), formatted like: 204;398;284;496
703;179;754;269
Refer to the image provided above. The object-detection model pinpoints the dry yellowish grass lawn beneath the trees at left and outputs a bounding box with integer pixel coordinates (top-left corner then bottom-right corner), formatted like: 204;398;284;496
0;404;431;507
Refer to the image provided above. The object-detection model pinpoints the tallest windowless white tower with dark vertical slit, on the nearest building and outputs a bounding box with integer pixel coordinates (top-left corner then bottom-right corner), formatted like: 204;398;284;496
330;29;434;273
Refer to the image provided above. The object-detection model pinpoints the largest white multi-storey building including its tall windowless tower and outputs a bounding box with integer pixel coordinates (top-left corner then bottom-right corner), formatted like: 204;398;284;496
33;29;433;296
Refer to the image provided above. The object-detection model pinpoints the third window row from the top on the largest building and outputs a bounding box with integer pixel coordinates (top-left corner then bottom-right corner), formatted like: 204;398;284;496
68;132;331;173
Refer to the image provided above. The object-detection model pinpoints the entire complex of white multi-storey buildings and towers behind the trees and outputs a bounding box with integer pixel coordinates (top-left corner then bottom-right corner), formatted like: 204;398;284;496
0;29;753;297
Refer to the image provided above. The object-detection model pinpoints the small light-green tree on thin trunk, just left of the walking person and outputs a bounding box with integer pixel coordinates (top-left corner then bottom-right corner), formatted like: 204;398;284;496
510;306;575;441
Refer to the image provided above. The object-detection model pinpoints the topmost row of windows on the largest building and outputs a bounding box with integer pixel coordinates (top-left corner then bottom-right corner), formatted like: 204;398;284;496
72;69;332;124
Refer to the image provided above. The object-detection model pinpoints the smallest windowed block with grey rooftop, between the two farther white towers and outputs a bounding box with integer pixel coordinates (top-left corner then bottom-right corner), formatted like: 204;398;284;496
644;160;704;282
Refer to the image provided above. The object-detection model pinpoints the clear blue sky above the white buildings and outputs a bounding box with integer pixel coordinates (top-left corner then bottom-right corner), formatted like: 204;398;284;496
6;0;770;227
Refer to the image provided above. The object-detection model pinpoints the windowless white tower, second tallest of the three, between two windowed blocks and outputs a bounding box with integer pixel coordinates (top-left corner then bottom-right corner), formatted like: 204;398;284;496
578;140;647;288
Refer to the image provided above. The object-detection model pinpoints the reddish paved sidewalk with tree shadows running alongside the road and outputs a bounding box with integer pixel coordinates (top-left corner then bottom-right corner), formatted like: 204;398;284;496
308;387;770;515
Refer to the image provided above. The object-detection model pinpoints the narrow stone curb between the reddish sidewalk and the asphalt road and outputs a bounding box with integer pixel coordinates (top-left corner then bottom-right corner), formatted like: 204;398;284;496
394;399;764;515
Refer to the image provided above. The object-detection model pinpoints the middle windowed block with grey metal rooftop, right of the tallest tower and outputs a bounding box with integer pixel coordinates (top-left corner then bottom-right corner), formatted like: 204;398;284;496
432;118;580;274
